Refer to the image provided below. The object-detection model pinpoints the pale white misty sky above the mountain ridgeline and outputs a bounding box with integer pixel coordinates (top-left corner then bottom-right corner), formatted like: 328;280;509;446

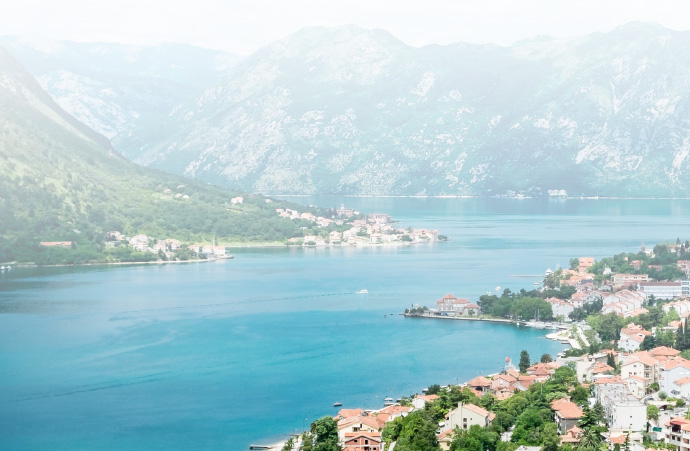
5;0;690;55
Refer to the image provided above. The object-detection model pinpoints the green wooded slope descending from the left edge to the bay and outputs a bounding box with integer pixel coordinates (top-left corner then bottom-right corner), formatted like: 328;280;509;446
0;48;330;264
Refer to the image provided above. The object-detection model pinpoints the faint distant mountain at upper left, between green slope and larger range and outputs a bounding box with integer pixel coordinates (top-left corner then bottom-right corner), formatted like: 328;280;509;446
0;36;237;152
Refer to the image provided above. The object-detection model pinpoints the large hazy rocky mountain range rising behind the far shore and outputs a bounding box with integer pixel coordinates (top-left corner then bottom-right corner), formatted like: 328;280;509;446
5;23;690;197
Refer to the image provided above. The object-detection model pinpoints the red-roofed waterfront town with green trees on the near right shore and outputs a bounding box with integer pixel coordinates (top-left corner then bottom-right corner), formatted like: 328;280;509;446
275;240;690;451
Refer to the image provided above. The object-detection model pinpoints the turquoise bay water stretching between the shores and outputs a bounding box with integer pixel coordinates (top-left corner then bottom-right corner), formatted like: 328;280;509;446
0;198;690;450
